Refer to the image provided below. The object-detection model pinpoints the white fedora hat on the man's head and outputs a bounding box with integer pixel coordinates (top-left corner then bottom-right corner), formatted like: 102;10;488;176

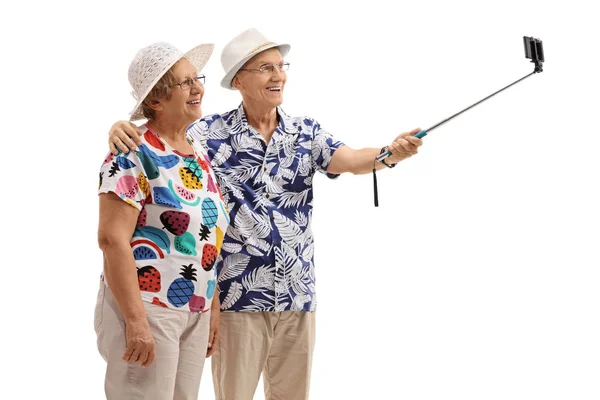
221;28;290;89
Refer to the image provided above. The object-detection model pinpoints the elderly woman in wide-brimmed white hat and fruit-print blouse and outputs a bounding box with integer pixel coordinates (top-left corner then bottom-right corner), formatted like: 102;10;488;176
95;43;229;400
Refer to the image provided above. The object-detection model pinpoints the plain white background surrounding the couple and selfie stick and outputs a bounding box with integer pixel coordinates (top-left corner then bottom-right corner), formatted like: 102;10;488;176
0;0;600;400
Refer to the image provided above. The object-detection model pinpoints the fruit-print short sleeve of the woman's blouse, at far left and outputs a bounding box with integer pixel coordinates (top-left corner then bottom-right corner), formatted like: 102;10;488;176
98;151;150;211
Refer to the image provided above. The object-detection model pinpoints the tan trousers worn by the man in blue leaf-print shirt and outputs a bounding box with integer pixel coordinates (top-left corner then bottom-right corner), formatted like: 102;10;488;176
211;311;315;400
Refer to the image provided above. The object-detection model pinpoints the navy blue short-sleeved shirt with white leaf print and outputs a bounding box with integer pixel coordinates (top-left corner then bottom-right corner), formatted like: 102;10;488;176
188;105;343;311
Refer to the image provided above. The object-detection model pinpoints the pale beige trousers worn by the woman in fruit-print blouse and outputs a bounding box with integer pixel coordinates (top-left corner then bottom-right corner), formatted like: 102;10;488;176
94;285;210;400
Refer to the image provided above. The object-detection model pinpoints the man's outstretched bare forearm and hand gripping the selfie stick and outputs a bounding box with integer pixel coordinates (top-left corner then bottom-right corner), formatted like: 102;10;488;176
327;128;423;175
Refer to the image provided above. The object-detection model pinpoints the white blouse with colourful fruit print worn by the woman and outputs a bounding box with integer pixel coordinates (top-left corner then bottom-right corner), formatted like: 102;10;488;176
98;126;229;312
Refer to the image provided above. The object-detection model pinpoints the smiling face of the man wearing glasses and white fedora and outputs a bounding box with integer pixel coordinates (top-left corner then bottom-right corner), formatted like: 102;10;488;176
233;48;287;108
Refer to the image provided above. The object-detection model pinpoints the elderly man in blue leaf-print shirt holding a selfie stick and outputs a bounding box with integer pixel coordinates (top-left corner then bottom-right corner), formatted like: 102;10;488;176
110;29;422;400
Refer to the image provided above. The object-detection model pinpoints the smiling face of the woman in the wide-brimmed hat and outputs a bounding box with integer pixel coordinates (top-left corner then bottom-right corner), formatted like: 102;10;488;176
156;58;204;125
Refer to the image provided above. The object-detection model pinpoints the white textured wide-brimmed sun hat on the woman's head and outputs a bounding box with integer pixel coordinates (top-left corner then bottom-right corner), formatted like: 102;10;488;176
129;42;214;121
